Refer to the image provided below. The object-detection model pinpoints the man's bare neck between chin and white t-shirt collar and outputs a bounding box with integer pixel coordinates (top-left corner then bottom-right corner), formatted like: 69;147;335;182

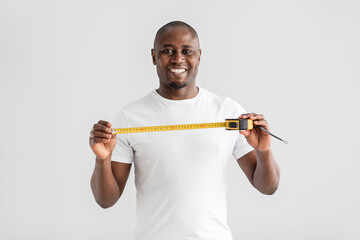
156;83;199;100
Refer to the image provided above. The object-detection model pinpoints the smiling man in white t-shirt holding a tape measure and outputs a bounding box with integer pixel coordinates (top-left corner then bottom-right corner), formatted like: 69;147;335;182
90;21;279;240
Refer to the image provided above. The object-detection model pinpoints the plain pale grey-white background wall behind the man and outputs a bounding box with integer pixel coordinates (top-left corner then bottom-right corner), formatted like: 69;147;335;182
0;0;360;240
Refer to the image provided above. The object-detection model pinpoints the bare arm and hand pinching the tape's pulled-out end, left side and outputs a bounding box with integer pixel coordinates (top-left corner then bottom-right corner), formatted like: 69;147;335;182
89;121;131;208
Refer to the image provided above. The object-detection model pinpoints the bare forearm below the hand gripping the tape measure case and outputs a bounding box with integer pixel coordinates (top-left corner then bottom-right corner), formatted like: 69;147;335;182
253;150;280;195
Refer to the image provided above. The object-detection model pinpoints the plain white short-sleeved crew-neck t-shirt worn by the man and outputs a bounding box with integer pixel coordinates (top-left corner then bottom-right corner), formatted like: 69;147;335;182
112;87;253;240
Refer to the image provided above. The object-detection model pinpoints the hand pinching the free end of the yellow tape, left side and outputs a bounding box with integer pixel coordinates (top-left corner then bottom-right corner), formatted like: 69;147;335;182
89;120;116;161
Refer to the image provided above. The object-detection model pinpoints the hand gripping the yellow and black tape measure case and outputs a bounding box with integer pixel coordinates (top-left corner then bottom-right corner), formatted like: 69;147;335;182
239;113;271;151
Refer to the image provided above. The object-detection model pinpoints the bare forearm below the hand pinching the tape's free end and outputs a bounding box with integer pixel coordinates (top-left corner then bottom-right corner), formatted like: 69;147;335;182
91;159;121;208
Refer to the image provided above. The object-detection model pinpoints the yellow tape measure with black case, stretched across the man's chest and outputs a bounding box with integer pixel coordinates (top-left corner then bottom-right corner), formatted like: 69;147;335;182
112;118;253;134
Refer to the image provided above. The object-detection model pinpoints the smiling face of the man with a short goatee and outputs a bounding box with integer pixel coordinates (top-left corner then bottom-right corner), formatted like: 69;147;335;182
151;27;201;89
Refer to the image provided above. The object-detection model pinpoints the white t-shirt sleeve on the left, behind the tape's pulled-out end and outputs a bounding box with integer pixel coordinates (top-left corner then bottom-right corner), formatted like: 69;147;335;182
111;111;134;163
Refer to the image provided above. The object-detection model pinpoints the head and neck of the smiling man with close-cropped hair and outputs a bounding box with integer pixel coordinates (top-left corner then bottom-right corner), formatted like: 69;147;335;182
151;23;201;100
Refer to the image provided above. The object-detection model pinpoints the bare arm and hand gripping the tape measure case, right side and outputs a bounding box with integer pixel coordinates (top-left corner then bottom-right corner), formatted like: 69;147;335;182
238;113;280;195
